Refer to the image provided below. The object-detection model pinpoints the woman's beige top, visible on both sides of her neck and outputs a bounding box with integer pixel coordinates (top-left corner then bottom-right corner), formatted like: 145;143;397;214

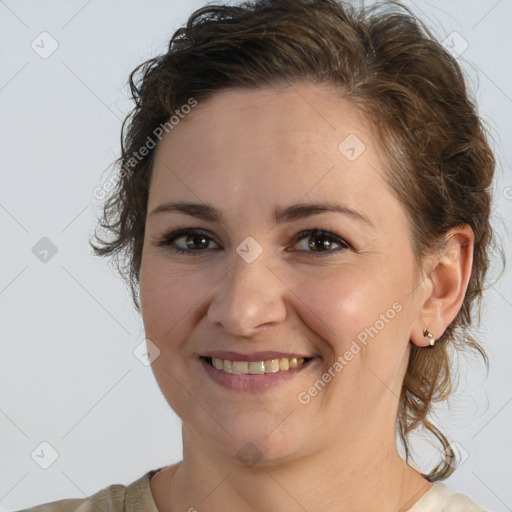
18;468;485;512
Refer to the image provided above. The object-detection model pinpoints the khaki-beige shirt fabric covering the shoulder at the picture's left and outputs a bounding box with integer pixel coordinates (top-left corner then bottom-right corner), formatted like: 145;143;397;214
14;468;161;512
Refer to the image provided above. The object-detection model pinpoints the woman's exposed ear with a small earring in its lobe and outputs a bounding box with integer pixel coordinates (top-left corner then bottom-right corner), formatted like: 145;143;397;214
410;224;474;347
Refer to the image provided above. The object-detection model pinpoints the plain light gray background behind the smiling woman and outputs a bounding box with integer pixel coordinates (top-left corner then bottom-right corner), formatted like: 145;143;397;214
0;0;512;512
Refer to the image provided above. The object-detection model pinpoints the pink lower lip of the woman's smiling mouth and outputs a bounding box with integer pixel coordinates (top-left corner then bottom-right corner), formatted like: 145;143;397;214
199;357;314;391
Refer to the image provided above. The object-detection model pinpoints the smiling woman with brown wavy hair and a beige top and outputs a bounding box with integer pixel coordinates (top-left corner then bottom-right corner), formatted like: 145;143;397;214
20;0;494;512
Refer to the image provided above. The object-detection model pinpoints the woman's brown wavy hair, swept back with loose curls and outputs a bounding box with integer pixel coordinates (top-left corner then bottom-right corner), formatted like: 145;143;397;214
90;0;495;481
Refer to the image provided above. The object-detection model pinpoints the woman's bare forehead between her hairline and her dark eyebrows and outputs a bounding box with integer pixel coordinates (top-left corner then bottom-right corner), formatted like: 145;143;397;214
150;84;396;226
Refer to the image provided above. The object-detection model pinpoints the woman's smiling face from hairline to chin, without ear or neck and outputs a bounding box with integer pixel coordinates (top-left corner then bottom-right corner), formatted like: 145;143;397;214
140;84;428;464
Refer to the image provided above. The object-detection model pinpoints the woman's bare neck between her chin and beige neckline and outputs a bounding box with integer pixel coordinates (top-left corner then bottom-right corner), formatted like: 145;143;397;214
152;428;431;512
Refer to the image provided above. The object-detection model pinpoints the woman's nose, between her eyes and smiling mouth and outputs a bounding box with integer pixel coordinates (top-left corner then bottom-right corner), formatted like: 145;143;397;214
207;246;288;337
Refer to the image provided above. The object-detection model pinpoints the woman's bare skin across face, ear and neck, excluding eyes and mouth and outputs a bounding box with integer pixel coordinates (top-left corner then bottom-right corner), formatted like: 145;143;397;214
140;84;473;512
